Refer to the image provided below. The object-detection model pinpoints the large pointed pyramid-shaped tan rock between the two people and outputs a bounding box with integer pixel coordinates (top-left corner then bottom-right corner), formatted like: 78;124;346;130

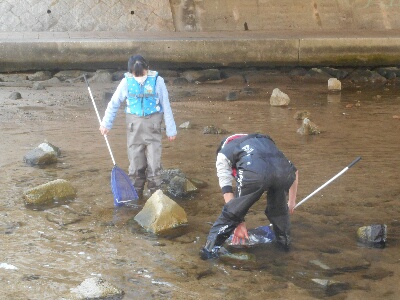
134;190;188;233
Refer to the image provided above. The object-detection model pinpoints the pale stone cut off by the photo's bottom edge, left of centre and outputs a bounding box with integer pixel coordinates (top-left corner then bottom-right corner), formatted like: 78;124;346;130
61;277;124;300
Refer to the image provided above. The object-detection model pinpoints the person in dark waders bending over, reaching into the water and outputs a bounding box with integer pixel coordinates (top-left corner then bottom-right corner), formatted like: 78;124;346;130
200;134;298;260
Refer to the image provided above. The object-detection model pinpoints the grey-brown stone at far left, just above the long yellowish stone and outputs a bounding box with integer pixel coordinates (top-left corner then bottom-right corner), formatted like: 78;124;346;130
24;142;61;166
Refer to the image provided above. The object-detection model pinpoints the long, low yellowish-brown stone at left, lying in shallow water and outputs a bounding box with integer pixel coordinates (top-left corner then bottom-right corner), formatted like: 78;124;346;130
24;179;76;205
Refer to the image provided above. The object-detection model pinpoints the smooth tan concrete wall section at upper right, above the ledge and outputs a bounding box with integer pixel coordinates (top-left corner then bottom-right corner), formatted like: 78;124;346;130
171;0;400;31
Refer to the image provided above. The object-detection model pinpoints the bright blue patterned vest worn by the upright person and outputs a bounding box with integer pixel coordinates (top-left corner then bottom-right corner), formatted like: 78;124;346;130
125;70;162;117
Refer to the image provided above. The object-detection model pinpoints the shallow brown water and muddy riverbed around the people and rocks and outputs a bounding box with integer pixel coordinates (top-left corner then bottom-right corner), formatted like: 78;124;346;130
0;69;400;300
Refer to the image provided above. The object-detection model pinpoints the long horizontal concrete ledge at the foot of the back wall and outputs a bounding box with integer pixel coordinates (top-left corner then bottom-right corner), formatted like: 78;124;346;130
0;31;400;72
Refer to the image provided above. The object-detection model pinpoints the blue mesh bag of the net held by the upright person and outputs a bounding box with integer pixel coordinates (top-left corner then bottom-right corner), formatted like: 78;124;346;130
111;166;139;206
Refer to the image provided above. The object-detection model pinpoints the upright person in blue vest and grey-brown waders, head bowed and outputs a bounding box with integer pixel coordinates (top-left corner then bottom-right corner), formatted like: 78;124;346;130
99;55;177;198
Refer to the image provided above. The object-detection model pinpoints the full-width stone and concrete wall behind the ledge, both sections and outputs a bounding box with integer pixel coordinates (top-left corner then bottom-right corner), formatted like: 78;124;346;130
0;0;400;32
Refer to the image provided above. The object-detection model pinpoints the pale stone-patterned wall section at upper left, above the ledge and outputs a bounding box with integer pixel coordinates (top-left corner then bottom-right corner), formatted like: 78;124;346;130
0;0;174;32
